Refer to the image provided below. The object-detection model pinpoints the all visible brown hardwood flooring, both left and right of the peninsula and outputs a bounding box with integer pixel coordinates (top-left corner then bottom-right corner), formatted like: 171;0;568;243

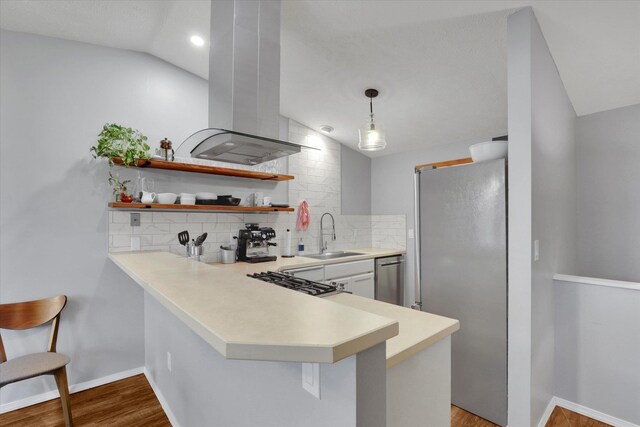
0;374;612;427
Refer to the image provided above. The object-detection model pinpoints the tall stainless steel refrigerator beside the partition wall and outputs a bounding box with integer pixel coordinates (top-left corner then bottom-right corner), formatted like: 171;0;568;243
415;159;507;426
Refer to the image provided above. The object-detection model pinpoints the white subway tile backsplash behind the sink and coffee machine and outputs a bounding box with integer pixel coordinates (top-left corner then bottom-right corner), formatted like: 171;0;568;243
108;120;406;262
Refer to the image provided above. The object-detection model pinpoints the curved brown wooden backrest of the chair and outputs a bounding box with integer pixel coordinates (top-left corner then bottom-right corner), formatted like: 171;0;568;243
0;295;67;363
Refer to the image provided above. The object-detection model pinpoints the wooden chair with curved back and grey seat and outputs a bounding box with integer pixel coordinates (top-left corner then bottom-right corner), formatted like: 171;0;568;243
0;295;73;427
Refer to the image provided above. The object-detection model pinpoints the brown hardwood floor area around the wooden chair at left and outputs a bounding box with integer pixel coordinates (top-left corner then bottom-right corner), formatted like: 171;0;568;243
0;374;171;427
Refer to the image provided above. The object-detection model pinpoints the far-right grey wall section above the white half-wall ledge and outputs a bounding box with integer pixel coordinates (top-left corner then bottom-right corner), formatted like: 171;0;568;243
577;105;640;282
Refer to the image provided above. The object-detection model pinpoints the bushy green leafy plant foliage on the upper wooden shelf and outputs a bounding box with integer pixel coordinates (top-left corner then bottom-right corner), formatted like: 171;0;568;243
89;123;151;167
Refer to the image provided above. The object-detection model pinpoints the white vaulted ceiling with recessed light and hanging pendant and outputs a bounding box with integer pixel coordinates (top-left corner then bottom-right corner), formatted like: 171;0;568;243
0;0;640;155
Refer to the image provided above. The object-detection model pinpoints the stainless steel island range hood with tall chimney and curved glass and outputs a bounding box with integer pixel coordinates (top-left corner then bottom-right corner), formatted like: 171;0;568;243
182;0;301;165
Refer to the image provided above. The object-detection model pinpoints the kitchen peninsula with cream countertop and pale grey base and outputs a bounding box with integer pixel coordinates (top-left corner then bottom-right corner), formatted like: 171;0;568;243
109;249;459;426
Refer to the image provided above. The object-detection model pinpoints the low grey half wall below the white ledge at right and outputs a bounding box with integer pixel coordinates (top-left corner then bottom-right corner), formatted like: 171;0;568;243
555;281;640;425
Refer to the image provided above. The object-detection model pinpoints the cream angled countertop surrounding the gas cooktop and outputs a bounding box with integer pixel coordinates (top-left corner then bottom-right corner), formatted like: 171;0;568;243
109;248;459;366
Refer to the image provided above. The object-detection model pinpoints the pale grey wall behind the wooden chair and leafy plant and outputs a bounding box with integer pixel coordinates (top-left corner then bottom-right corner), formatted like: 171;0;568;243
0;31;207;403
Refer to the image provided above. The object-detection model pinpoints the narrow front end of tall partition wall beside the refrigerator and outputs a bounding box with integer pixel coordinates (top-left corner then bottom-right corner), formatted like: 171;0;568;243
507;9;534;426
